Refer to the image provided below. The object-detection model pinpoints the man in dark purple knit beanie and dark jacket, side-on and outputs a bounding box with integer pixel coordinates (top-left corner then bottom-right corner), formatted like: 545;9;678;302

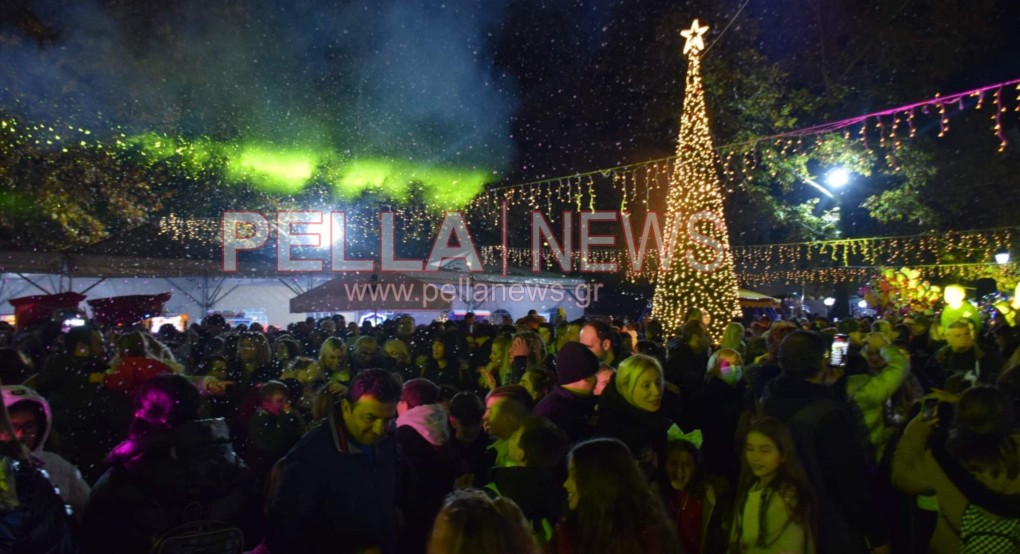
534;343;599;444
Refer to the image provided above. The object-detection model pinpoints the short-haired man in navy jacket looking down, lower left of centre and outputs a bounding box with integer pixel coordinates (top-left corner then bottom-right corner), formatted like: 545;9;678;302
266;369;401;554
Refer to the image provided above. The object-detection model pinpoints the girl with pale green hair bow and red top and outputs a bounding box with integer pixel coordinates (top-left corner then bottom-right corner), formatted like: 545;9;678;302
662;439;725;554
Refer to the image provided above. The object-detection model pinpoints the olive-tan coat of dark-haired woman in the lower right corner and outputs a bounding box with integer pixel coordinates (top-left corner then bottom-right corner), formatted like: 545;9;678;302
891;417;1020;554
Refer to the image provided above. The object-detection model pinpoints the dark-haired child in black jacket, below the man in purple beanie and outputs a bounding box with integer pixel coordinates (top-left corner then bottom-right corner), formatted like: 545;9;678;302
486;416;567;543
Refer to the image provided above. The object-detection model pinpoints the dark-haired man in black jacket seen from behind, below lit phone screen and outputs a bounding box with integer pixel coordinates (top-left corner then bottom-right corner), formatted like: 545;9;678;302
764;331;889;554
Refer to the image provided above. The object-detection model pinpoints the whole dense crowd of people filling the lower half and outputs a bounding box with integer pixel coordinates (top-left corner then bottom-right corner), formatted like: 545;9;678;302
0;310;1020;554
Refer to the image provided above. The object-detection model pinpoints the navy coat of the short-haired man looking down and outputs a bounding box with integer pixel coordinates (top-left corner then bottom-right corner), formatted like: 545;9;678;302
266;406;397;554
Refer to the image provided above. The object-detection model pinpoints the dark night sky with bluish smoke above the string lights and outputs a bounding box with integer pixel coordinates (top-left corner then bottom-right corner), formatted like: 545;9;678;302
0;0;1020;236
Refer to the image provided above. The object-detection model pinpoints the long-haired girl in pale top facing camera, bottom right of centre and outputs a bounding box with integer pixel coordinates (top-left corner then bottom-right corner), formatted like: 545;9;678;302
730;417;815;554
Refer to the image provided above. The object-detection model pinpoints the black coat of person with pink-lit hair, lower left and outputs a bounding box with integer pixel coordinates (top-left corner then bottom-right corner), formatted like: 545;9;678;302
82;418;262;554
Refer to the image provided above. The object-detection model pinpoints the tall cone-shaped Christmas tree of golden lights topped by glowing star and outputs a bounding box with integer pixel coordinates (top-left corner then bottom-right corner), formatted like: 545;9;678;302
652;19;741;340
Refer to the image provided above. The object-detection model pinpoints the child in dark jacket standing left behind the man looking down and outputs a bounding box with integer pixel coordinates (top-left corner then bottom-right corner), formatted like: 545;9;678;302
245;381;305;481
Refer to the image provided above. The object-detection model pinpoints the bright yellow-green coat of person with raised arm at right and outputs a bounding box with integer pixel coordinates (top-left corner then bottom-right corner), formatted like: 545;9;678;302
847;345;910;460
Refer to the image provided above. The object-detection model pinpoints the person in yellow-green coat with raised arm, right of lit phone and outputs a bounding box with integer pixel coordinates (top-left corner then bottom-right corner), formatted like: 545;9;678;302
847;333;910;461
